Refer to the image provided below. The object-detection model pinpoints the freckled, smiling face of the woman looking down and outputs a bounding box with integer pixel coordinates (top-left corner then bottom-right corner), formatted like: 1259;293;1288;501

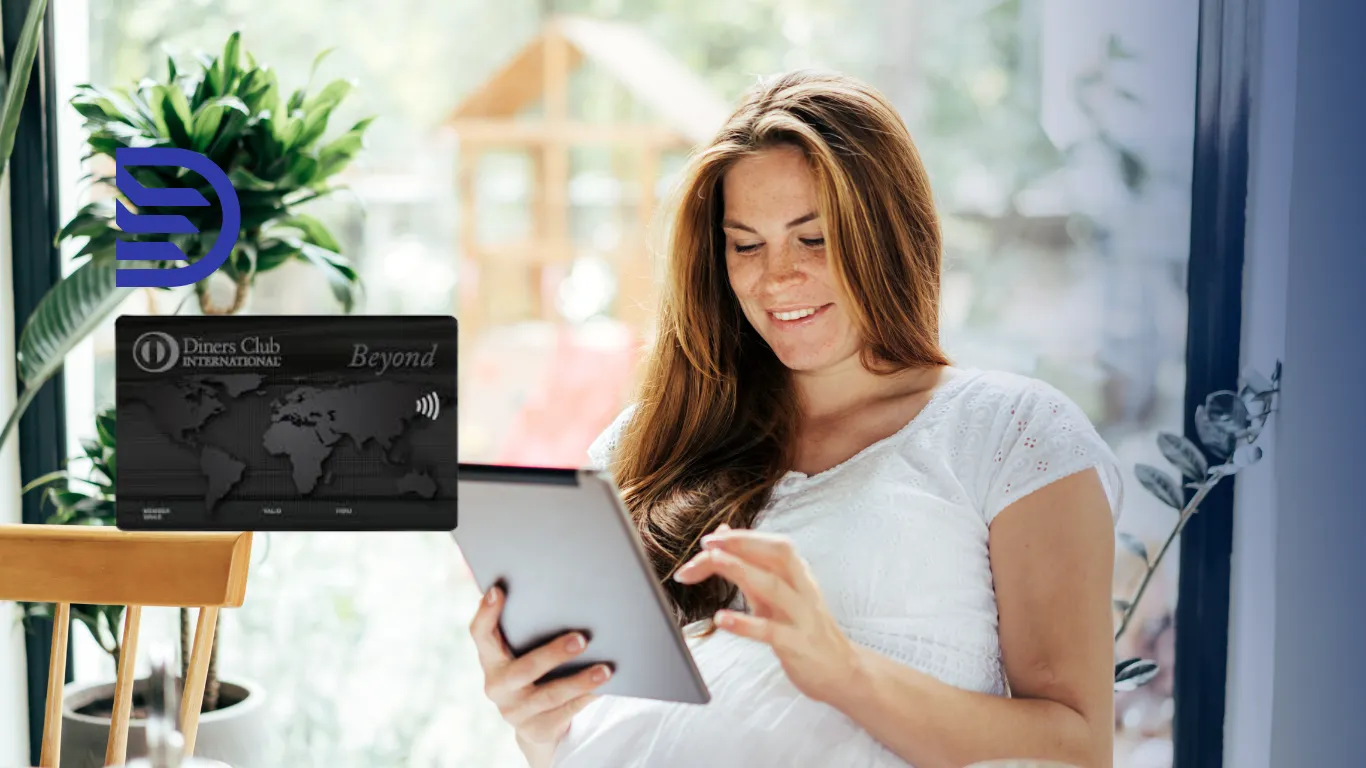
721;146;859;372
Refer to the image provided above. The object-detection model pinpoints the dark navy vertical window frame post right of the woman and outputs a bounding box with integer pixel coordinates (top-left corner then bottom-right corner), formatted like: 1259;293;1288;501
1172;0;1254;768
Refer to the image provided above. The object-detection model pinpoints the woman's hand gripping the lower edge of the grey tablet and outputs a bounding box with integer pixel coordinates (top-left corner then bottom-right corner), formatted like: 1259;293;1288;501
470;586;612;765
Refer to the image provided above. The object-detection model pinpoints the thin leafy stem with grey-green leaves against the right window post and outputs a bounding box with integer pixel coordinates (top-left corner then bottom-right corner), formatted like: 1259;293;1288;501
1115;362;1281;690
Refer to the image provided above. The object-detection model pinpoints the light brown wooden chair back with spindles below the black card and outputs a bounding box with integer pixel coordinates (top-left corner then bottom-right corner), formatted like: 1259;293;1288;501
0;525;251;768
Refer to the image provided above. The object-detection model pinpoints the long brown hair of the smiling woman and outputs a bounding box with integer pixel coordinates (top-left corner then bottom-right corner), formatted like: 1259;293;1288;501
611;71;948;625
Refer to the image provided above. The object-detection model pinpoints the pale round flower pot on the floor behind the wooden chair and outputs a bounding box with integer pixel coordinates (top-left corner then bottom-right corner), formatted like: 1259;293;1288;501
61;679;269;768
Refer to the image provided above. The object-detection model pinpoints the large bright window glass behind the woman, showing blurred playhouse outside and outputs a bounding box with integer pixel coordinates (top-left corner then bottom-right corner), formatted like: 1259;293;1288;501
45;0;1197;768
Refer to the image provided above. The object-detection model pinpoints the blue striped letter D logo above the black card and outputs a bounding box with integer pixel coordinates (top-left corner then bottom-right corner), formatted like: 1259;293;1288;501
113;146;242;288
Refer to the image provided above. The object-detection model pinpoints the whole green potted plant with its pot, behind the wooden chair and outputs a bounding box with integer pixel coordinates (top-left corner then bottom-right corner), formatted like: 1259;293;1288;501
0;26;370;768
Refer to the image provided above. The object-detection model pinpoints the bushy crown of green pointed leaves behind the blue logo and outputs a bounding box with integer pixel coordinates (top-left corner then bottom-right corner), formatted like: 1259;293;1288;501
57;33;372;314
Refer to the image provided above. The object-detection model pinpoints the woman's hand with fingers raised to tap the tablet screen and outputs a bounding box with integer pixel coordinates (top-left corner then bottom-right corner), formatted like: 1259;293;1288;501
673;525;858;701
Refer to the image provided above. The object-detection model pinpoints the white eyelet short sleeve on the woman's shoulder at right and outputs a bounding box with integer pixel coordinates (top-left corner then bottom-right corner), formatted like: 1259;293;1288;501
982;379;1124;525
